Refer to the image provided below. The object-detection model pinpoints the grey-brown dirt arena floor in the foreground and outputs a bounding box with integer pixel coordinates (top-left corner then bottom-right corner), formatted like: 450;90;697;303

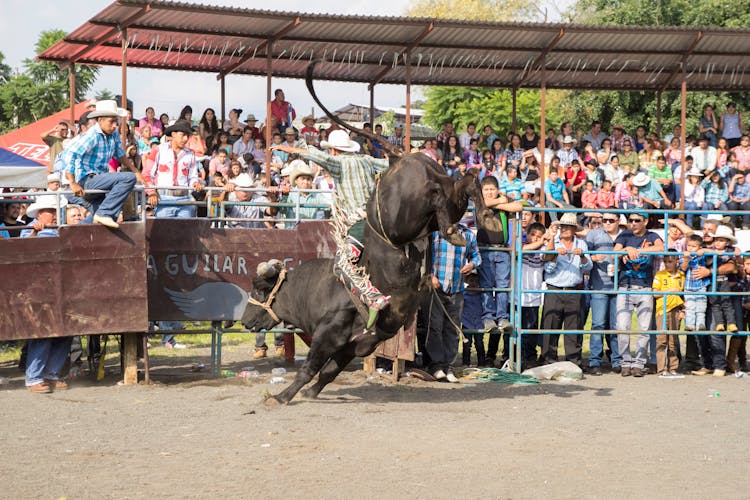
0;343;750;499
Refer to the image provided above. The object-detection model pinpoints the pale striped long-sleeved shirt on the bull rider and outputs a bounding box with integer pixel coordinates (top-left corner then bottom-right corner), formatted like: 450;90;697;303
300;146;388;212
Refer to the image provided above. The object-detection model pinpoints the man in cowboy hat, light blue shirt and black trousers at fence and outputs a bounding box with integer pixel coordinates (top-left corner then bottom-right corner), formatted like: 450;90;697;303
542;213;592;366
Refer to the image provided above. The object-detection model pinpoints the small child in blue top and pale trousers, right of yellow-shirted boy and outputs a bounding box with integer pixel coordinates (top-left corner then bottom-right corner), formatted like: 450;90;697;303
680;234;711;332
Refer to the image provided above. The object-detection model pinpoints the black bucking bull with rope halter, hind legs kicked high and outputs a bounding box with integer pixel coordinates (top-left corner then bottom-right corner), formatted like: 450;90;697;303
242;62;500;404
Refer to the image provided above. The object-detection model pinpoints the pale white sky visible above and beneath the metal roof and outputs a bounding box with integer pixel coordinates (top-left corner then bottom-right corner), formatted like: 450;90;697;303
0;0;570;123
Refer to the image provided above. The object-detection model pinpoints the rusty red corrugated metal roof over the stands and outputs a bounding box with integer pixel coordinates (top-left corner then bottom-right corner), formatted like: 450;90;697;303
39;0;750;91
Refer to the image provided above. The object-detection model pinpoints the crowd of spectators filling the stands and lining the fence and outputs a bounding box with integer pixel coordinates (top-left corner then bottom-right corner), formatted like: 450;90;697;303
0;94;750;390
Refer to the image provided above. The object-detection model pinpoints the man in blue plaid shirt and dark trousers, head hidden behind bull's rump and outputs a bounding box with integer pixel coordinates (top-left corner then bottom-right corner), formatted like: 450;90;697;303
423;224;481;383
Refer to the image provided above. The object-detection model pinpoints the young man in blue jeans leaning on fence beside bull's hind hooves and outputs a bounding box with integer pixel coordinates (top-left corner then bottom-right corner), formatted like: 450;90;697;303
477;175;522;364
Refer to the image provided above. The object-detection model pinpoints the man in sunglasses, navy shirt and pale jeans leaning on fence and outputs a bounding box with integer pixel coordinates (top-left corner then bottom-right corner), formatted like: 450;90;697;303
614;213;664;377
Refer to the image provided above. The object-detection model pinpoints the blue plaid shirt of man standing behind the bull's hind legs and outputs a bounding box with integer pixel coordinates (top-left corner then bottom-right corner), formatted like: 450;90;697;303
431;224;482;295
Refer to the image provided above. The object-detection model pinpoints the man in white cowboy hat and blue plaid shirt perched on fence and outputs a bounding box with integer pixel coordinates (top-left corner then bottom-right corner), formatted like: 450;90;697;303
61;101;143;229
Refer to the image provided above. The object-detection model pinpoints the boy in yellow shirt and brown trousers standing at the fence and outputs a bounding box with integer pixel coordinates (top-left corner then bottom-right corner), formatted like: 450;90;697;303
652;254;685;376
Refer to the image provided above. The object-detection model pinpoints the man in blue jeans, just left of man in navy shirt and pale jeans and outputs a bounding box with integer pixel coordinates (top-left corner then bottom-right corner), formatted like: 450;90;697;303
586;212;622;375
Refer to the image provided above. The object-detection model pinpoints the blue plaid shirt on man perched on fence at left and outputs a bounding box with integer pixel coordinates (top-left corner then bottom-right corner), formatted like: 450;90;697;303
60;123;125;182
